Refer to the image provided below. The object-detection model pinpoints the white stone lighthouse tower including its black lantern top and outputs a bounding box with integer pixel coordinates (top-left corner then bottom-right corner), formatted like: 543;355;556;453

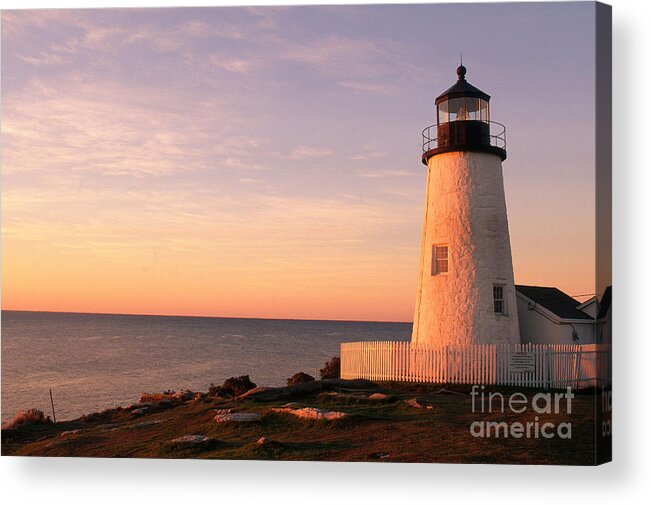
412;65;520;346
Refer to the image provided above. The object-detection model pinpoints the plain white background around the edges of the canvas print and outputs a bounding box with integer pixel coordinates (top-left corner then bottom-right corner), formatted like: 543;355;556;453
0;0;651;505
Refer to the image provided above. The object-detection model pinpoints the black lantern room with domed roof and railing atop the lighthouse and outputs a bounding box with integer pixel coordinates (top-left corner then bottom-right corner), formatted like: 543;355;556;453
422;65;506;165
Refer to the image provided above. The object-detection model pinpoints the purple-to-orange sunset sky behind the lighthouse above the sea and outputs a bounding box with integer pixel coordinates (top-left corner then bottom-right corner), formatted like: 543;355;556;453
1;2;596;321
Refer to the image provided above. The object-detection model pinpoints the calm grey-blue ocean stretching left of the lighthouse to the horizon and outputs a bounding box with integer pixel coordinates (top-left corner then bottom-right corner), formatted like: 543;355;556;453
2;311;411;423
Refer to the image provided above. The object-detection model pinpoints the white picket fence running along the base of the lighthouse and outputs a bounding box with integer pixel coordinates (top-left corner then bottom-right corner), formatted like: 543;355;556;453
341;342;611;388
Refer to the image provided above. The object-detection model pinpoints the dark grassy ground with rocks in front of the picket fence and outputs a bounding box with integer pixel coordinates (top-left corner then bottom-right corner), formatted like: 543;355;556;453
2;383;608;465
